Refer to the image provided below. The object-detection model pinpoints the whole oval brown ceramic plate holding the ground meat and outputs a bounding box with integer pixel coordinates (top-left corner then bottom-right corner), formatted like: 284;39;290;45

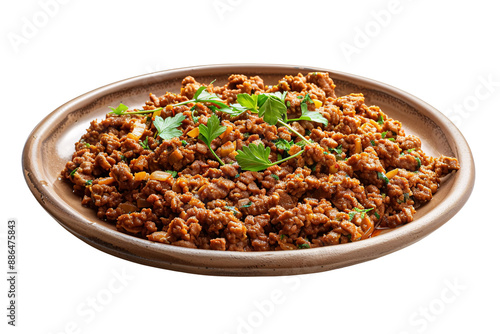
23;64;474;276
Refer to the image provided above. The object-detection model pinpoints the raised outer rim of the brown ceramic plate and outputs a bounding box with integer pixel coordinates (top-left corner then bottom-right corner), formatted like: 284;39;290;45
22;63;475;276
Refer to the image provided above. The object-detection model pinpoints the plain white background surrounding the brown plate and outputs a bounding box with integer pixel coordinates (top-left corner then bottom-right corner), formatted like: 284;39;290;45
0;0;500;334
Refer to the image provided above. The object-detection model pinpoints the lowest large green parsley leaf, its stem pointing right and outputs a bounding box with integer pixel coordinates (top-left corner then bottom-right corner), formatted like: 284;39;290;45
236;143;304;172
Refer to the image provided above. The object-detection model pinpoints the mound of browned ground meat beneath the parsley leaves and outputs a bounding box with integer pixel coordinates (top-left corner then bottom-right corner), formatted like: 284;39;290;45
62;72;460;251
